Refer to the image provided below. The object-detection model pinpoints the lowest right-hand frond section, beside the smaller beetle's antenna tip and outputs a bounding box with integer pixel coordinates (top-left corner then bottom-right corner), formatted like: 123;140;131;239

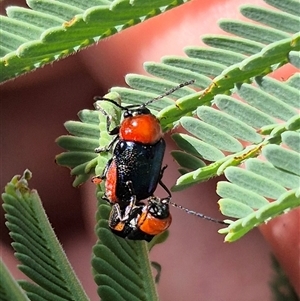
217;139;300;241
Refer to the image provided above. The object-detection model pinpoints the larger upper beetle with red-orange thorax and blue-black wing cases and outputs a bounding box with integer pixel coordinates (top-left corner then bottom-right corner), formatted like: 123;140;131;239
92;80;194;210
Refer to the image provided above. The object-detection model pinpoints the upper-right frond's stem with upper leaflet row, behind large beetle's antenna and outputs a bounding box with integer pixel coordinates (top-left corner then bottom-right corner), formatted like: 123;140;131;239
104;0;300;129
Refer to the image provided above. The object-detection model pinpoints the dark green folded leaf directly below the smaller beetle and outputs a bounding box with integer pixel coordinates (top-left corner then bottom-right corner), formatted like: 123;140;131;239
92;197;158;301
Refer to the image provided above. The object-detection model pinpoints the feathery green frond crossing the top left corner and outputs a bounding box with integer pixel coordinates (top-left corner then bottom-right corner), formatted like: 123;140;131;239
0;0;190;82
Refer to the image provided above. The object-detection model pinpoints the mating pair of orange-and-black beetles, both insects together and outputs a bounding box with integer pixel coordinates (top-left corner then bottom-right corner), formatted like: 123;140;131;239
92;81;223;241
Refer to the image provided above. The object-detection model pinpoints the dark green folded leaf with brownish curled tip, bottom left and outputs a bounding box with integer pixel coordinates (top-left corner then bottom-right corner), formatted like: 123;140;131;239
2;171;88;301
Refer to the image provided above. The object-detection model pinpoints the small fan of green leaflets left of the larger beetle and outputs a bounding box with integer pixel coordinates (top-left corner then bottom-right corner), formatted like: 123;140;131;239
56;92;120;186
